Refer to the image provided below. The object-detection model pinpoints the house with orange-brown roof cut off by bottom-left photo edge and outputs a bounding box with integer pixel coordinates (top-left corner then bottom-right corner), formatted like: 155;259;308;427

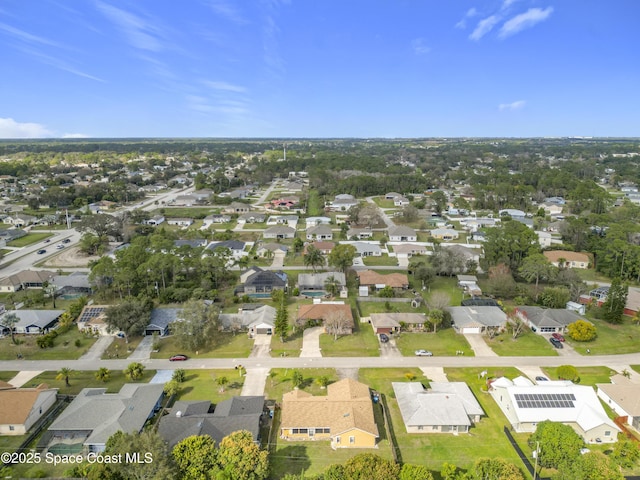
0;381;58;435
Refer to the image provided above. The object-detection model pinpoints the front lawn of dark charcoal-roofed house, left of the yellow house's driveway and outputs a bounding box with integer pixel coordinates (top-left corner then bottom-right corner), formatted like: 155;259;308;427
177;370;244;404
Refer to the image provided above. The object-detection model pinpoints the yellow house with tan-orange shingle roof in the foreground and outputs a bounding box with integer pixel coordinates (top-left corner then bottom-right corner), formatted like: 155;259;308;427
280;378;378;449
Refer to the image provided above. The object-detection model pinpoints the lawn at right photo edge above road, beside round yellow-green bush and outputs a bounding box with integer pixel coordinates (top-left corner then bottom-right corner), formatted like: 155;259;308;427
565;317;640;355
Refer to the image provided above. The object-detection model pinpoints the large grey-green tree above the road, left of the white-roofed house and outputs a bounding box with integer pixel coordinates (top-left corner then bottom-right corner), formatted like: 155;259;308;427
169;300;219;351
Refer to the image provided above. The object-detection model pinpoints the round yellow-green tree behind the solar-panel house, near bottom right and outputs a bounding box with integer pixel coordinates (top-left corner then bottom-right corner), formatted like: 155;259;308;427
529;420;584;468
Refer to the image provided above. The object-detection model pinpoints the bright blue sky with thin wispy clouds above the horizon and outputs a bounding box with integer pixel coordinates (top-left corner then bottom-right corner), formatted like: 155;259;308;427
0;0;640;138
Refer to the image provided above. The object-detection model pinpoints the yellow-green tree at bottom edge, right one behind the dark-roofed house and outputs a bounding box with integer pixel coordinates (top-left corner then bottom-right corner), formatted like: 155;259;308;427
218;430;269;480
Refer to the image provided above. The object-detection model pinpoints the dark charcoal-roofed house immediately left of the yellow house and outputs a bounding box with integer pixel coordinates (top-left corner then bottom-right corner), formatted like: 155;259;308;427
158;396;265;449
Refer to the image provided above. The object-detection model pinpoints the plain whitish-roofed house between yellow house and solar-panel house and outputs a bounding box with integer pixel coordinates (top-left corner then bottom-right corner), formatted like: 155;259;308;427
391;382;484;435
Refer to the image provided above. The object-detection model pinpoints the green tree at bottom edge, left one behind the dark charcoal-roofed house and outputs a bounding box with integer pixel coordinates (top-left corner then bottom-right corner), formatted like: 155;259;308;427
171;435;220;480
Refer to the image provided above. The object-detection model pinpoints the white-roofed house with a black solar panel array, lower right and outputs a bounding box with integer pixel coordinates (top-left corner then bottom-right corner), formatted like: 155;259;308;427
489;377;621;443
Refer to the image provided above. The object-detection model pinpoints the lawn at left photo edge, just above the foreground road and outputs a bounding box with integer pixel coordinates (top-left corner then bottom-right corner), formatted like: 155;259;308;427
0;327;96;360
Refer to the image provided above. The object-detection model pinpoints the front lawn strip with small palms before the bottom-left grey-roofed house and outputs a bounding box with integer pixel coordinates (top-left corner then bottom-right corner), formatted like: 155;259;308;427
24;370;156;395
